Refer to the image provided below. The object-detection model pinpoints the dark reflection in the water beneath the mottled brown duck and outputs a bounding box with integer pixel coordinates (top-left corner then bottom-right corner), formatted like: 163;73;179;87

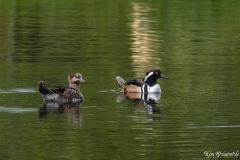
39;101;82;126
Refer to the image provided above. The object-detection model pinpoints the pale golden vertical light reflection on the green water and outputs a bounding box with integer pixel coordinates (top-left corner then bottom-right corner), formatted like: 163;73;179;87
130;3;160;77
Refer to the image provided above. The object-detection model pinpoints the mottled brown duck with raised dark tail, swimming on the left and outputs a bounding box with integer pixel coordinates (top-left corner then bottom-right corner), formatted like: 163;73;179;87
38;73;86;102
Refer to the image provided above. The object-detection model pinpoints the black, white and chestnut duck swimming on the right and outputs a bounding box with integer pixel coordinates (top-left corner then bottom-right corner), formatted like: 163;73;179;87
116;68;169;93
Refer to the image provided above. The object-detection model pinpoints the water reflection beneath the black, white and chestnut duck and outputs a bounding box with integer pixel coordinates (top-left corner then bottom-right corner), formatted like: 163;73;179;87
117;92;161;116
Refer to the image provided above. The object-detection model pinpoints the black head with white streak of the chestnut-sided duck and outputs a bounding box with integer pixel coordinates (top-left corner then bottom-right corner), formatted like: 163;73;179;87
143;68;169;85
